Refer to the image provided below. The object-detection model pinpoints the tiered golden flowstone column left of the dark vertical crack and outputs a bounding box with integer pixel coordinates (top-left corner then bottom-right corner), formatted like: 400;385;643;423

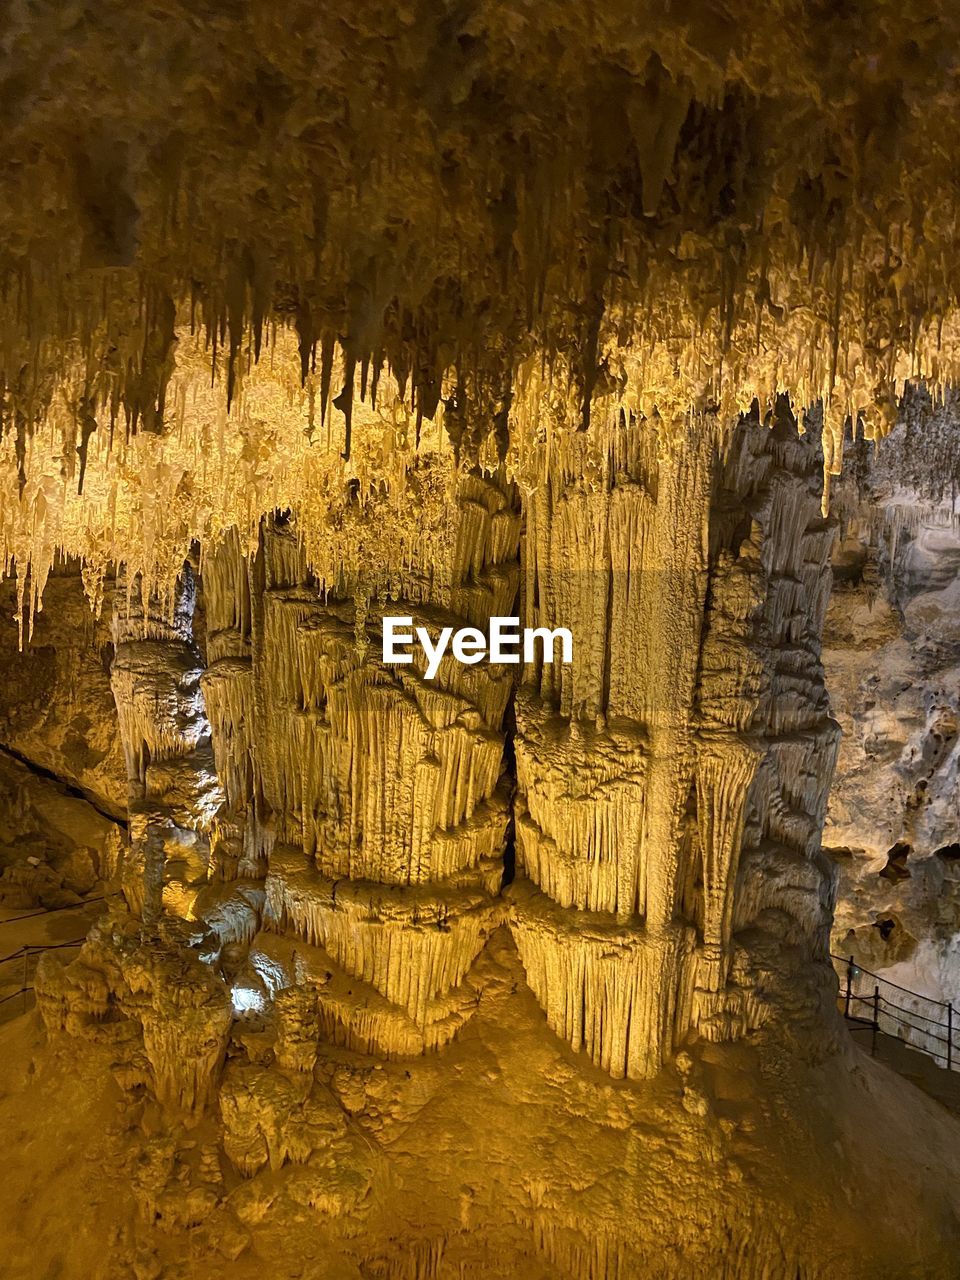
253;475;520;1053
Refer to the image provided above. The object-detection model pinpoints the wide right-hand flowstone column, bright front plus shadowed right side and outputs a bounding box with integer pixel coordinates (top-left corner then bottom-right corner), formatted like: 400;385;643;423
511;404;835;1078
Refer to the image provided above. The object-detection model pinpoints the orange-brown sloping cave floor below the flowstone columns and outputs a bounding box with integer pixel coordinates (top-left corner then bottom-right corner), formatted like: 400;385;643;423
0;936;960;1280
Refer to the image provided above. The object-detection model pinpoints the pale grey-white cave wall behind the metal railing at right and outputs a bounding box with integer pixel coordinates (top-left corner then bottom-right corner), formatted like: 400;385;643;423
823;481;960;1018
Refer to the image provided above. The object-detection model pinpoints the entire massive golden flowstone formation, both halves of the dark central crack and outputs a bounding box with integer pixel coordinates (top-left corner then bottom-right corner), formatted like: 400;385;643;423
84;403;836;1076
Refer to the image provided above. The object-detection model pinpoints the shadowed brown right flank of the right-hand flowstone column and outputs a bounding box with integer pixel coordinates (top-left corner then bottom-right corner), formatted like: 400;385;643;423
694;401;840;1039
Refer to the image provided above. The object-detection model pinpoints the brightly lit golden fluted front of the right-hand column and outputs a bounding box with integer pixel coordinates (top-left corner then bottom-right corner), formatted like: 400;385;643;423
512;420;717;1076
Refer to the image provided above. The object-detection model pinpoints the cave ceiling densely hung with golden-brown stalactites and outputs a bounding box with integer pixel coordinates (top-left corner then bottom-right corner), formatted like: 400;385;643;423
0;0;960;616
